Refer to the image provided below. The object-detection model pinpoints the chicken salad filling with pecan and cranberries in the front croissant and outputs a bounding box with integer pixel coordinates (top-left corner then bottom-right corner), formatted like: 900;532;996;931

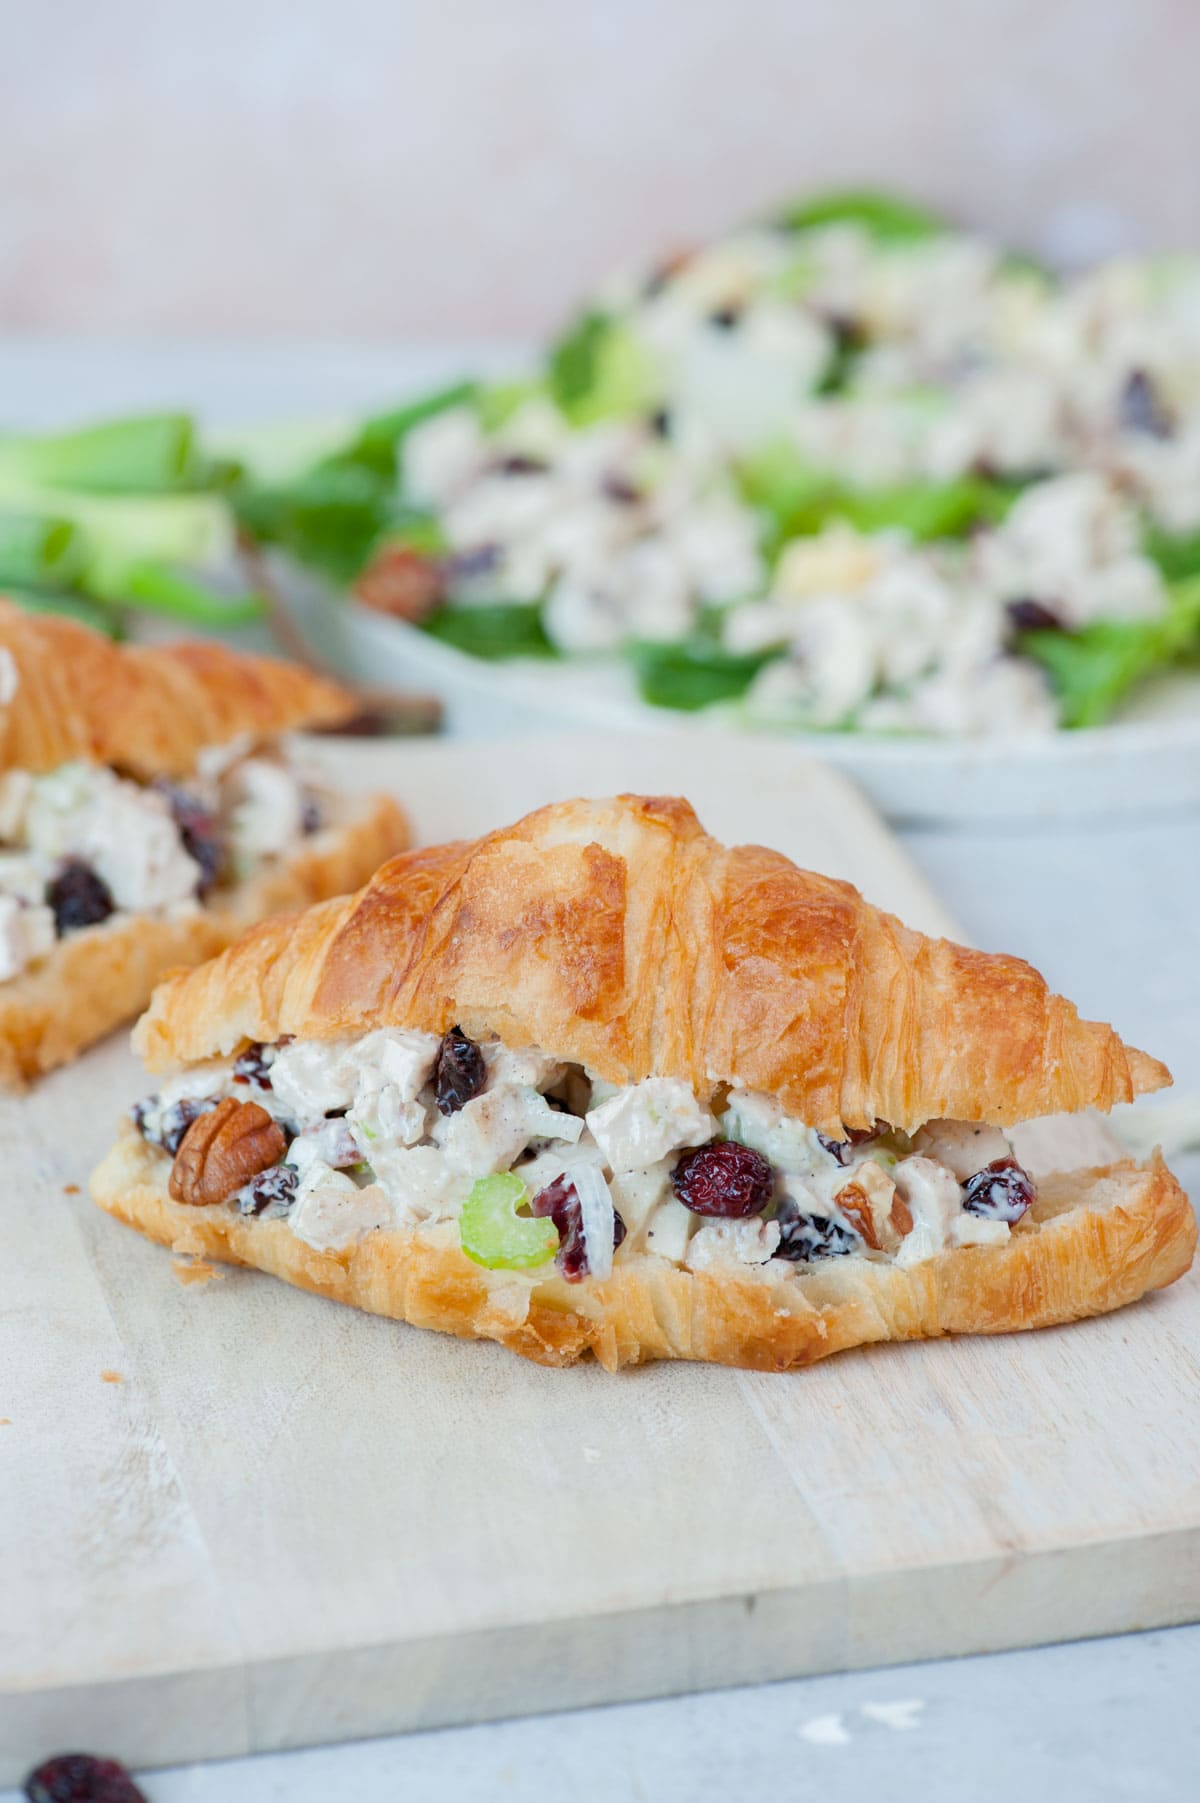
133;1028;1036;1282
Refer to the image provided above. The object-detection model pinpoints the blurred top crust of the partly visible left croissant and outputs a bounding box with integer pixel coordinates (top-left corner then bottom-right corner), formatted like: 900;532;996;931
0;600;355;779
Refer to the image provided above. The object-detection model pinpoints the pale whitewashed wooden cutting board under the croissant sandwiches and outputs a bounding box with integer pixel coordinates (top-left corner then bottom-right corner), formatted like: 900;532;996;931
0;736;1200;1781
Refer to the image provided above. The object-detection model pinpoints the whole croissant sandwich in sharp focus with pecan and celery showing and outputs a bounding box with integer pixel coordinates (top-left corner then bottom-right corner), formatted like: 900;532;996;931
92;795;1196;1368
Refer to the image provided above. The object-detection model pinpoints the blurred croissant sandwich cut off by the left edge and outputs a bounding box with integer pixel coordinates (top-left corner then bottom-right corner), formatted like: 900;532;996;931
0;600;409;1084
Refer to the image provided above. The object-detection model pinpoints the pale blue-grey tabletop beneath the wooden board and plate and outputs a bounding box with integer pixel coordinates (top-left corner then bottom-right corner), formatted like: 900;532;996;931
0;344;1200;1803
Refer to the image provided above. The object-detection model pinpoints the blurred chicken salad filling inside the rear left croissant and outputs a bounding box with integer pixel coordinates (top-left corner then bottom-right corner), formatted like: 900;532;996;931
0;739;333;981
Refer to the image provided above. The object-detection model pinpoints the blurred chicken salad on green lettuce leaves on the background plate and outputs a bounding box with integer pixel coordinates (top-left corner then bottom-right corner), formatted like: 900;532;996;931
317;197;1200;736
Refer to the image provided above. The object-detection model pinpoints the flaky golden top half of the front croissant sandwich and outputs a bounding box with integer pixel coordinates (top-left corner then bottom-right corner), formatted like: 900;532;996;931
135;795;1171;1134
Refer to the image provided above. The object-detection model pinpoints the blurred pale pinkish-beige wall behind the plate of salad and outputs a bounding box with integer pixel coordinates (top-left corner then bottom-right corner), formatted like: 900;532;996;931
0;0;1200;341
